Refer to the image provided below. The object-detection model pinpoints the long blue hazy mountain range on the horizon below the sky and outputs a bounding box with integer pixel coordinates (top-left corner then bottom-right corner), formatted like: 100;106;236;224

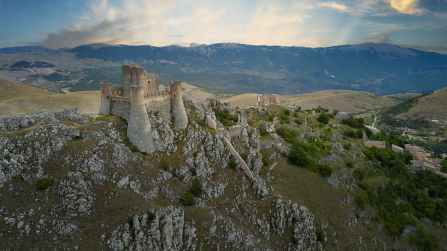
69;43;447;94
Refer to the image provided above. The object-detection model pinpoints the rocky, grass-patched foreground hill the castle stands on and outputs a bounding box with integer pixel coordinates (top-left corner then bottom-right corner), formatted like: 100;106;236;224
0;99;447;250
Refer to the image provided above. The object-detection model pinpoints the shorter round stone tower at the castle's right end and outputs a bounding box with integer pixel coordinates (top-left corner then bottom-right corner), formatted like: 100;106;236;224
170;81;188;130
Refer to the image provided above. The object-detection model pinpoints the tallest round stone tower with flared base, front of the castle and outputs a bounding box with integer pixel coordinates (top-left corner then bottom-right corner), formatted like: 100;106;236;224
128;67;156;153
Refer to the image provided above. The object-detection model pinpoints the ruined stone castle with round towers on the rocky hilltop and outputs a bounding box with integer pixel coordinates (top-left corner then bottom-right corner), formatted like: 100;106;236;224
99;65;188;153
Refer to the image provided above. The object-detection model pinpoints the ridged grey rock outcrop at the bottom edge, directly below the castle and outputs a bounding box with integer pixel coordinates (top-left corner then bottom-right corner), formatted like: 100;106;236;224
107;207;197;251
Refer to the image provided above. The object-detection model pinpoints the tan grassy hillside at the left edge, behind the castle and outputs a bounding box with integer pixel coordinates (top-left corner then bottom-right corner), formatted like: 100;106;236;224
0;80;100;116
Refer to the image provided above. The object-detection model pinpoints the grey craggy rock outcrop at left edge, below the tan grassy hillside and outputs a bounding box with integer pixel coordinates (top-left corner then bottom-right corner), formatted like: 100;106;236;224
0;111;85;187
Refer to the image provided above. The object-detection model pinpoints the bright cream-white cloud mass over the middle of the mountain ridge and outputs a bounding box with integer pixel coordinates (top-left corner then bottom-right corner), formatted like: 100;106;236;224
43;0;332;48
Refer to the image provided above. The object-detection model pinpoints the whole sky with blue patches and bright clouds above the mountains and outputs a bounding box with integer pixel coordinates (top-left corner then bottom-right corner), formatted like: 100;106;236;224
0;0;447;52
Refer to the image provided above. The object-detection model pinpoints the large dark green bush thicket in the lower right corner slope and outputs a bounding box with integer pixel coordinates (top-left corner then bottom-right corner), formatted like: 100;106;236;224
353;148;447;250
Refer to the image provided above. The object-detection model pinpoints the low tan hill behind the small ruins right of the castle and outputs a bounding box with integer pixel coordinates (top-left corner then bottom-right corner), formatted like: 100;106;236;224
224;90;401;112
